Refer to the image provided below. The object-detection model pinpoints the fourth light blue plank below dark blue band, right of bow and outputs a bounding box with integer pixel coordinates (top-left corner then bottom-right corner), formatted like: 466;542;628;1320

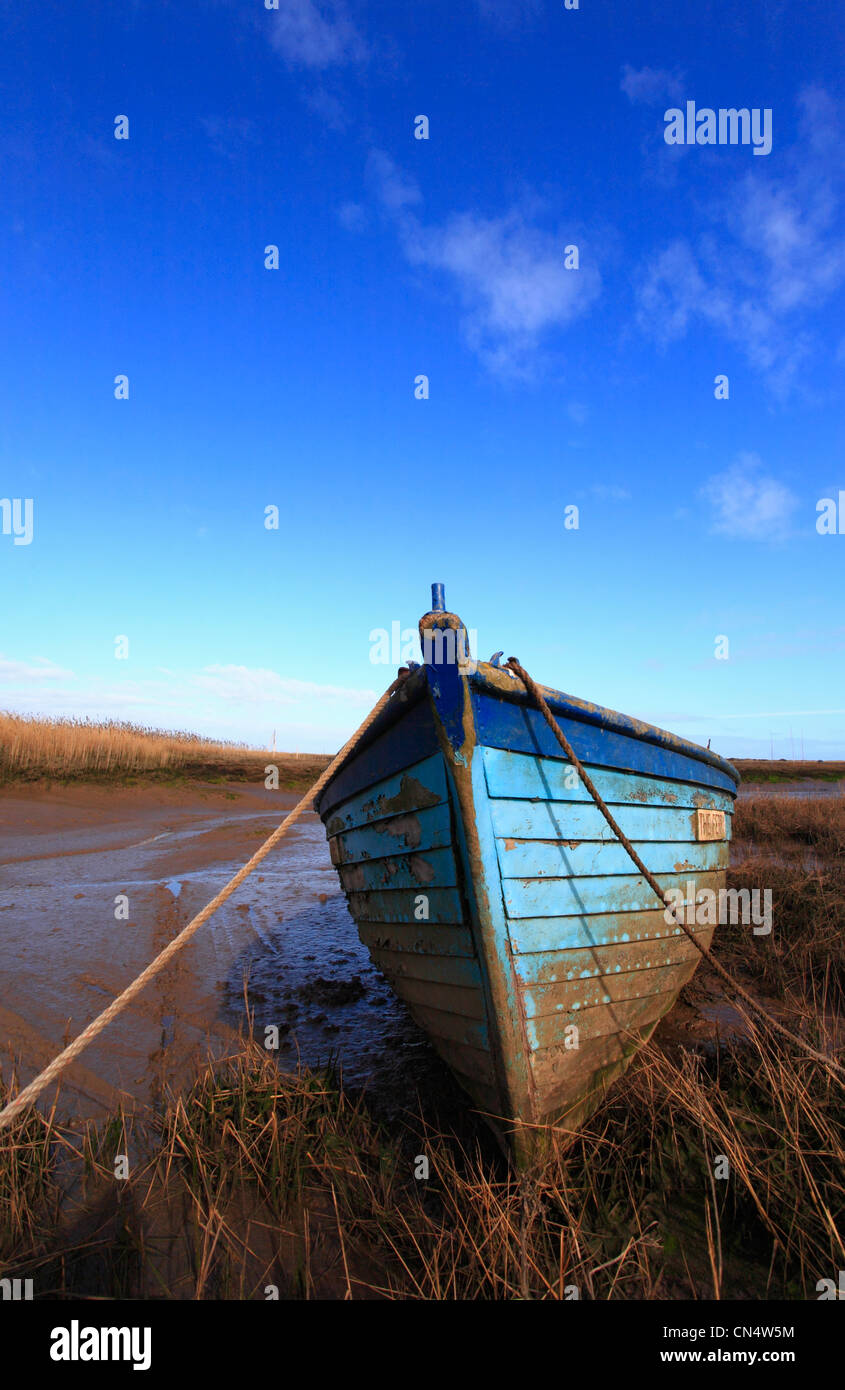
502;870;724;920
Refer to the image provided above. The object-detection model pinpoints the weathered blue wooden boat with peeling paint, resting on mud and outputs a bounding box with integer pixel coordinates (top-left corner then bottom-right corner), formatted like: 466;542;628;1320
317;585;739;1162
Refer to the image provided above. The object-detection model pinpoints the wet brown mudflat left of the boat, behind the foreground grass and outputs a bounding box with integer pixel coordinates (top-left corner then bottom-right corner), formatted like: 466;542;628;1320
0;783;417;1115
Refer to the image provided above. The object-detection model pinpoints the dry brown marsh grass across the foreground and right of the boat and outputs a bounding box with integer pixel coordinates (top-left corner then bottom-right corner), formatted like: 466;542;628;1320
0;802;845;1300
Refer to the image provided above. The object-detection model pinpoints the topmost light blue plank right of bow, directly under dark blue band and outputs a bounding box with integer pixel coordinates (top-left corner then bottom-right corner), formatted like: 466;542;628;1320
482;748;734;812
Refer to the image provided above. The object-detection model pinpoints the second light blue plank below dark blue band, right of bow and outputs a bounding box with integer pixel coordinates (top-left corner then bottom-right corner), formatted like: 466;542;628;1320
491;799;730;844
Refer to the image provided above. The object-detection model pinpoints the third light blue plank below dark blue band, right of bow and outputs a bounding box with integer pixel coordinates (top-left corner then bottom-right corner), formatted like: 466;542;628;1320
496;838;731;878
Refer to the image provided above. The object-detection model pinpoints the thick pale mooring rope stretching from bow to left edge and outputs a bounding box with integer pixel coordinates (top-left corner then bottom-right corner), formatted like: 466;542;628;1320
0;673;407;1129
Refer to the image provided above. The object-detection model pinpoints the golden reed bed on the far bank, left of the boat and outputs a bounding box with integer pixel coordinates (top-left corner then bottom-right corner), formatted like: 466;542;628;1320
0;712;328;783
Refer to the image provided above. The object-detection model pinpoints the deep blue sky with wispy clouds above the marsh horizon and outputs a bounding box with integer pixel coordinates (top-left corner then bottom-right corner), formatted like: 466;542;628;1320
0;0;845;758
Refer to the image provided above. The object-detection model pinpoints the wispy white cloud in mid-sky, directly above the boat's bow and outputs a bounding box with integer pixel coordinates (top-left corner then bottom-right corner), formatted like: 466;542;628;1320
368;150;600;378
